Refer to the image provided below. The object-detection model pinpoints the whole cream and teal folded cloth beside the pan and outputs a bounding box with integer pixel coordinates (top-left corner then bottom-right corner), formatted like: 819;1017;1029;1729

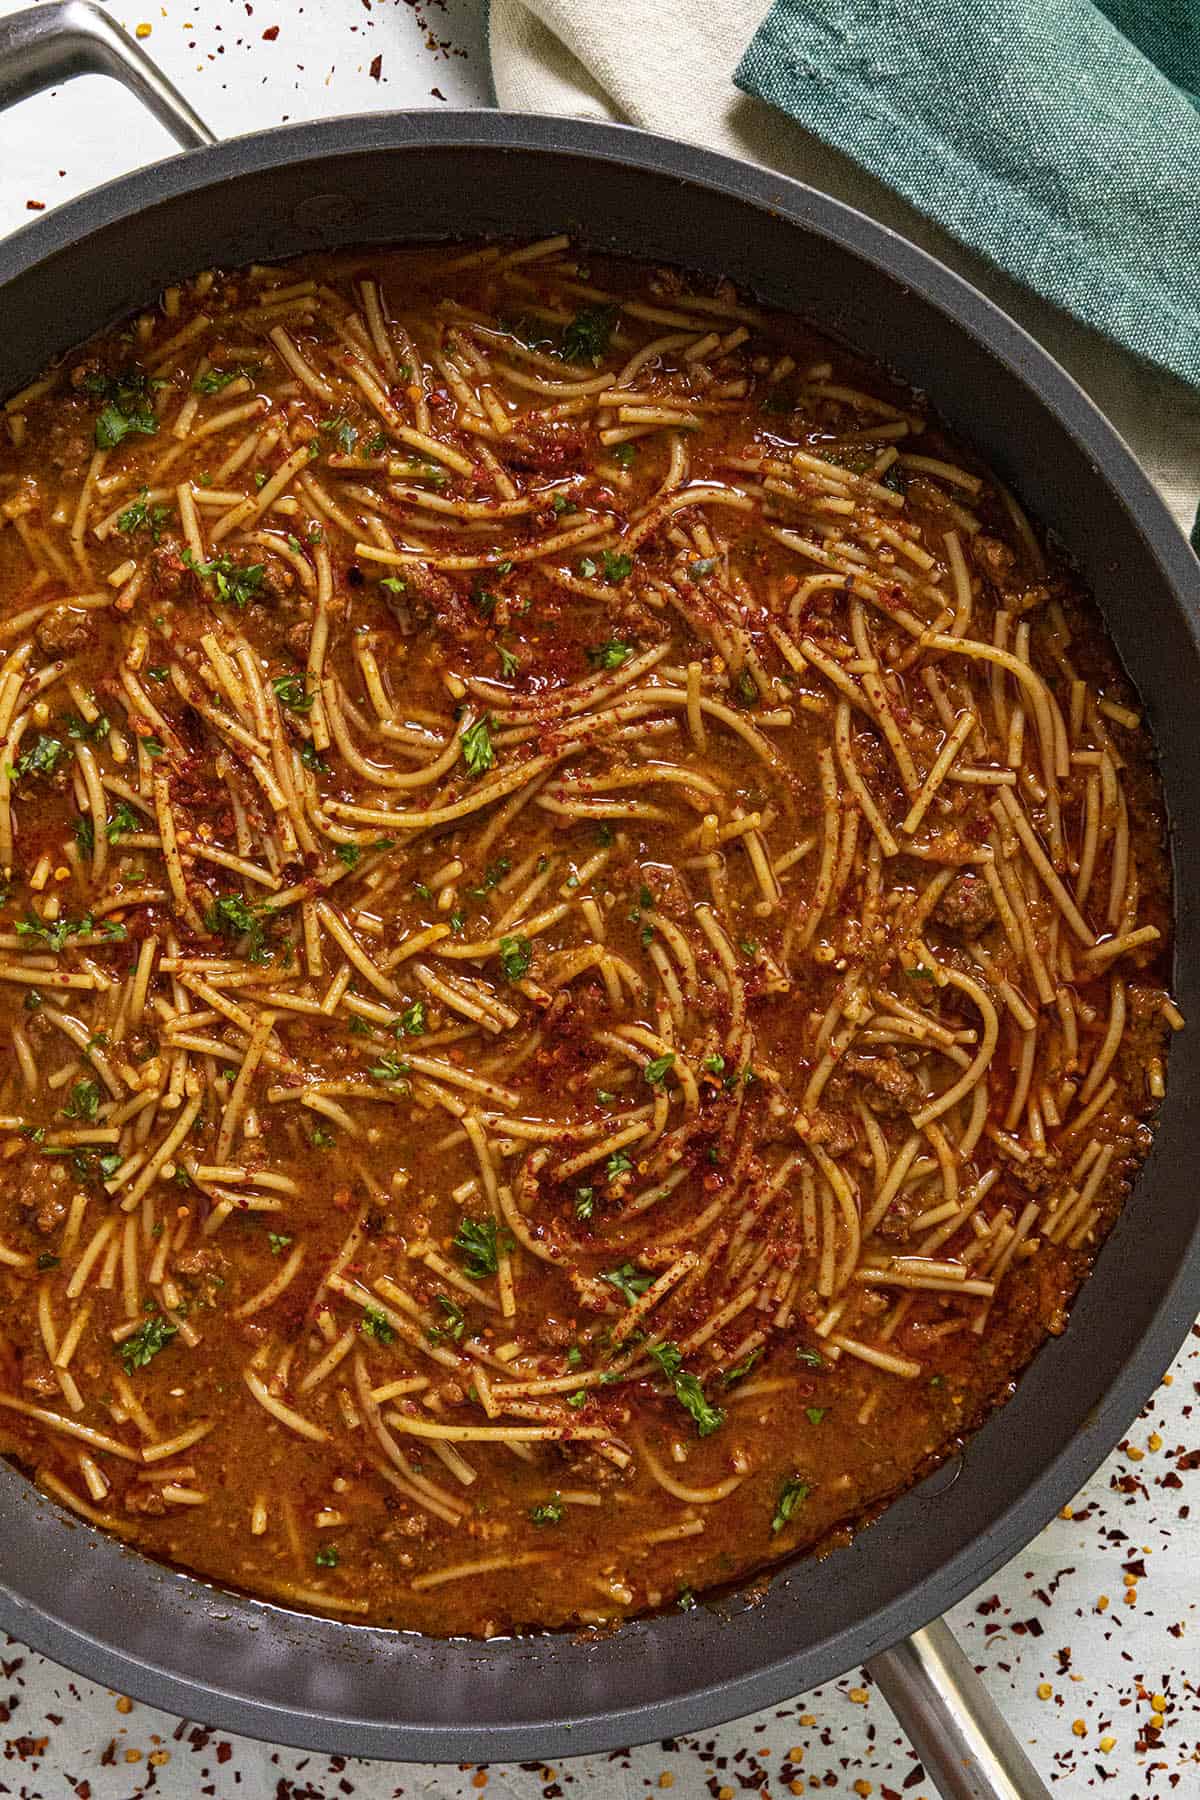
489;0;1200;524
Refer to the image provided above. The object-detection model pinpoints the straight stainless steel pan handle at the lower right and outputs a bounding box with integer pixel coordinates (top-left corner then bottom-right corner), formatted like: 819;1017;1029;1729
867;1618;1049;1800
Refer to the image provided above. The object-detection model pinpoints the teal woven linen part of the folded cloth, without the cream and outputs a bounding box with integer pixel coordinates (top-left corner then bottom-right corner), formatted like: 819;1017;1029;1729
736;0;1200;385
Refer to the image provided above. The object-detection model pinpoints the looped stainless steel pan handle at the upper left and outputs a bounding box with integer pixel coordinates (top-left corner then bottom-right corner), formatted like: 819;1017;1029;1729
0;0;216;149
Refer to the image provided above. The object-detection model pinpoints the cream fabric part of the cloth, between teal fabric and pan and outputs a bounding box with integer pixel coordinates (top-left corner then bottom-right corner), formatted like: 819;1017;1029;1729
489;0;1200;531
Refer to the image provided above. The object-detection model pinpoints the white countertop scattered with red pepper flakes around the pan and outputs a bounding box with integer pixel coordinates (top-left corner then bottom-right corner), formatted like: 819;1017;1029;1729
0;0;1200;1800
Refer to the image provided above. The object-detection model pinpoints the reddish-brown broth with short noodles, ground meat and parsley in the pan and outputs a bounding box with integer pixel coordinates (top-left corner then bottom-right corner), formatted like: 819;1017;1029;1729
0;239;1182;1633
